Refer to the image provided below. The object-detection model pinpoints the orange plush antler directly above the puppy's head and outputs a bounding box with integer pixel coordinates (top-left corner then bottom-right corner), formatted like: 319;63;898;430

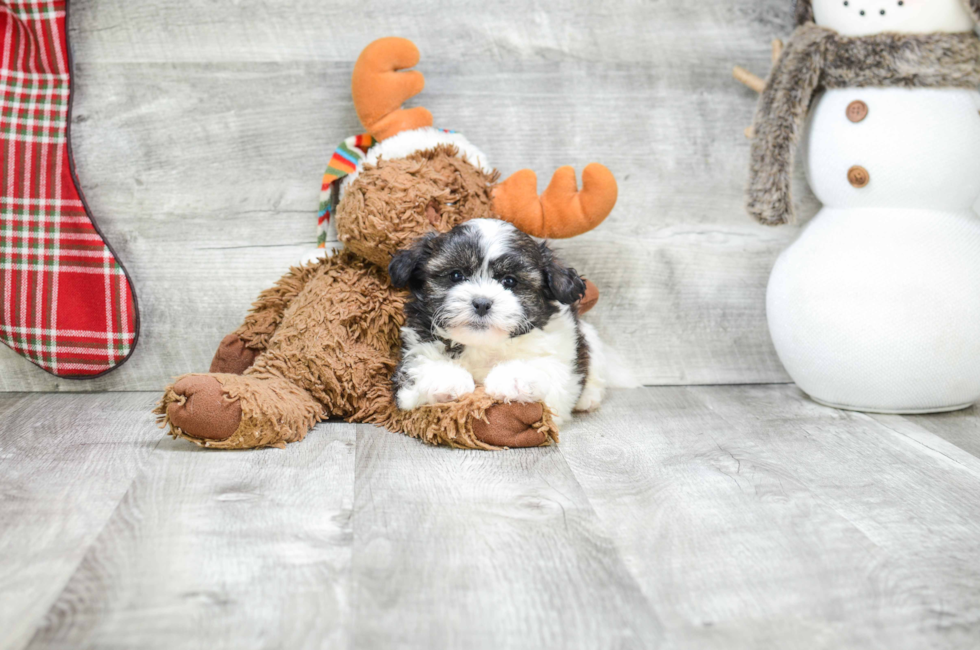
493;163;619;239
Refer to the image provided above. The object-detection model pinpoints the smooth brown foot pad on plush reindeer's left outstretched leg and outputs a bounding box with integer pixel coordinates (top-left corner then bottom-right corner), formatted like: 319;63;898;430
167;375;242;440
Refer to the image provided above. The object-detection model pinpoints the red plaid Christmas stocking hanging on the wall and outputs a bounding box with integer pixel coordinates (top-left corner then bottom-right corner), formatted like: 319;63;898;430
0;0;139;378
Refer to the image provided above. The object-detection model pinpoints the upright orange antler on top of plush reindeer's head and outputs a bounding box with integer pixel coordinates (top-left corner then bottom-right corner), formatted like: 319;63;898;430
351;36;432;140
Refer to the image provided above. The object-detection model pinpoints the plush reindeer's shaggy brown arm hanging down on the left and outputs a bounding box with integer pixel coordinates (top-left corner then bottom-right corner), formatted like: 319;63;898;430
211;262;322;375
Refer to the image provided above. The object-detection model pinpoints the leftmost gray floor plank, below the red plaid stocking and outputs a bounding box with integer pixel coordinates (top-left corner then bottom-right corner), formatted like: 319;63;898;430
0;393;160;650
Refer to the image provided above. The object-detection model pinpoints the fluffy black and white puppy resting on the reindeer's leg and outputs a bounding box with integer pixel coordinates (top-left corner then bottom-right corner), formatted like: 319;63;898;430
388;219;624;419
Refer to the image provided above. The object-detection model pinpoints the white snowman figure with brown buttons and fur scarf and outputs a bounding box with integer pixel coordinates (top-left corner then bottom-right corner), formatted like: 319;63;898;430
743;0;980;413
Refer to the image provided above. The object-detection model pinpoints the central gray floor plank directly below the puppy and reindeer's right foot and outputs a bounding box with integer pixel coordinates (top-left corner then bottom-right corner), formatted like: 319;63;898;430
353;426;660;649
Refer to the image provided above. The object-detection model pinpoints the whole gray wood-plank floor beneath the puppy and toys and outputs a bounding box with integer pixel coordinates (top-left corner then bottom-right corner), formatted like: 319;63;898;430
0;385;980;650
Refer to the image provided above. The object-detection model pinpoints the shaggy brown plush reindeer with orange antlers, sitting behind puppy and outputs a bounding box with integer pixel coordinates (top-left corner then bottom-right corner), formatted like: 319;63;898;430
156;38;617;449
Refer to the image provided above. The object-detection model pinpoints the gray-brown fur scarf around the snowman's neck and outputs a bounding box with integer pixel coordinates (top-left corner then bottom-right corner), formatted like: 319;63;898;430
747;22;980;225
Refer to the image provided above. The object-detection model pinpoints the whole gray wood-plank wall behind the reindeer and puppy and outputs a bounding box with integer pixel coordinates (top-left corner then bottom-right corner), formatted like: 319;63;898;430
0;0;804;384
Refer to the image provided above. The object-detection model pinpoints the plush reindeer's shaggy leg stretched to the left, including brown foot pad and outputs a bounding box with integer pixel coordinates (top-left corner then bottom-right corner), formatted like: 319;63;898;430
155;374;323;449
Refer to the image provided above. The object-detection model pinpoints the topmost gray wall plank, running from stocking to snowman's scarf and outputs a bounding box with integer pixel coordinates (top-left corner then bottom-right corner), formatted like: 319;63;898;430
63;0;792;64
